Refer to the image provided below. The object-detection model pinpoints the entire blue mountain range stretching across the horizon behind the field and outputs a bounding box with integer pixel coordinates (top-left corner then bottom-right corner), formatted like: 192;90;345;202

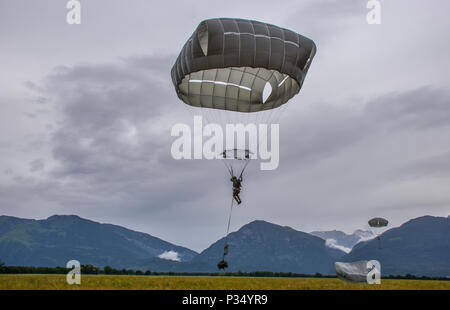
0;215;450;276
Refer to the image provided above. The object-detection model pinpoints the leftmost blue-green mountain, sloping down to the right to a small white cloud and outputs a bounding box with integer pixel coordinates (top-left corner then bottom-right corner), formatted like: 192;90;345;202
0;215;197;267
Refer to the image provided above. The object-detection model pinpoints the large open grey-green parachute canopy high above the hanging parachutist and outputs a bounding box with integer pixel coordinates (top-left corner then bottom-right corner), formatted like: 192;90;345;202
171;18;316;112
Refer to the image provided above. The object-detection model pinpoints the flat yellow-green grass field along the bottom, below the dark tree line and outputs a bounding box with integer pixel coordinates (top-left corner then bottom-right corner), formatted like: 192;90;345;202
0;274;450;290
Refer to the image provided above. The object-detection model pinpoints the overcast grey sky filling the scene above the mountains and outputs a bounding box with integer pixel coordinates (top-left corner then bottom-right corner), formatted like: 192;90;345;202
0;0;450;251
